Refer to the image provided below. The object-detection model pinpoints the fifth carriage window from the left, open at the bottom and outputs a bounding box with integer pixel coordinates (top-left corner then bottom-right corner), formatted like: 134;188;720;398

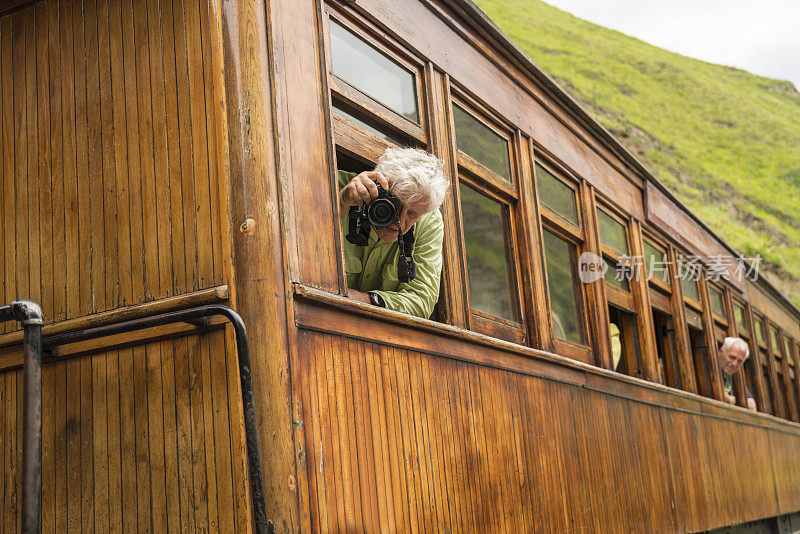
642;235;683;389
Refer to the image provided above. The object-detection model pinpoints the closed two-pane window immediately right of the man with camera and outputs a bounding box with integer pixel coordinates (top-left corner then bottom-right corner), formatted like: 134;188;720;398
451;96;527;343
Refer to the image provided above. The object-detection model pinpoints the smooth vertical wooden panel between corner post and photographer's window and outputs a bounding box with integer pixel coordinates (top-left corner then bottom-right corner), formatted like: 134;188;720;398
272;0;346;292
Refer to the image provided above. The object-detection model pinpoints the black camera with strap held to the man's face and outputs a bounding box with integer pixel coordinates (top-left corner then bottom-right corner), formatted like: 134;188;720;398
345;182;417;283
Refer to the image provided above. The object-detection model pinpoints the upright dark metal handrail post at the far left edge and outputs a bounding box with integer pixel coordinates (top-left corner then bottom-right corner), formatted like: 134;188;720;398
0;300;44;534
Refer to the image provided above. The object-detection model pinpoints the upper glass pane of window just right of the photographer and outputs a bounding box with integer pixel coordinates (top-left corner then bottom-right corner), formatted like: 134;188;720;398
453;104;511;182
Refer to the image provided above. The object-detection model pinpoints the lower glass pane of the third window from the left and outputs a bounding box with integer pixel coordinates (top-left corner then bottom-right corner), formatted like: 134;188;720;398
543;230;584;343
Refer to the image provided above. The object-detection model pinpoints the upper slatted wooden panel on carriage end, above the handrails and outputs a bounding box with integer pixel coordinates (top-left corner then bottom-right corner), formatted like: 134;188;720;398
0;0;227;328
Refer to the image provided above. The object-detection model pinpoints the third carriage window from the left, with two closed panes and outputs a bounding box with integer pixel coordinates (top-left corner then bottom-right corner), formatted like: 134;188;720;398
534;160;594;363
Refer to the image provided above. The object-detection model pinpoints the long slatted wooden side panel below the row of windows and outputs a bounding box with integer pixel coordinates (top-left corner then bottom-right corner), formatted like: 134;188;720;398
295;330;800;532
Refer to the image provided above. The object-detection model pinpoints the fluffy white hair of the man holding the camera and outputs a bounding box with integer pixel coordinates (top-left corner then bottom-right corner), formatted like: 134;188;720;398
375;148;450;211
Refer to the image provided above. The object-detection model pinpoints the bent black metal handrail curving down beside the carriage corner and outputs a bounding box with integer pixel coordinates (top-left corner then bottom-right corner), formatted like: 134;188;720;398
43;304;269;534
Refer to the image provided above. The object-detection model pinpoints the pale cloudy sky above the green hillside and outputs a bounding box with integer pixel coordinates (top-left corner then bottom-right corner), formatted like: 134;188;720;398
545;0;800;89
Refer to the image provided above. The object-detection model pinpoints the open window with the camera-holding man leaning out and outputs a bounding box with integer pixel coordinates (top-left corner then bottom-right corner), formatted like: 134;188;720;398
324;6;450;319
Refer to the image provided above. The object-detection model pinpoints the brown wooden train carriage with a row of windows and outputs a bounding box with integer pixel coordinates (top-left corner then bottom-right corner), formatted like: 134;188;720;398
0;0;800;532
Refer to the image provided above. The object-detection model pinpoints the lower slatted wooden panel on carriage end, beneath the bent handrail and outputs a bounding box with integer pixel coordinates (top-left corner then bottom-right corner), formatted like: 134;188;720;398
0;330;249;532
